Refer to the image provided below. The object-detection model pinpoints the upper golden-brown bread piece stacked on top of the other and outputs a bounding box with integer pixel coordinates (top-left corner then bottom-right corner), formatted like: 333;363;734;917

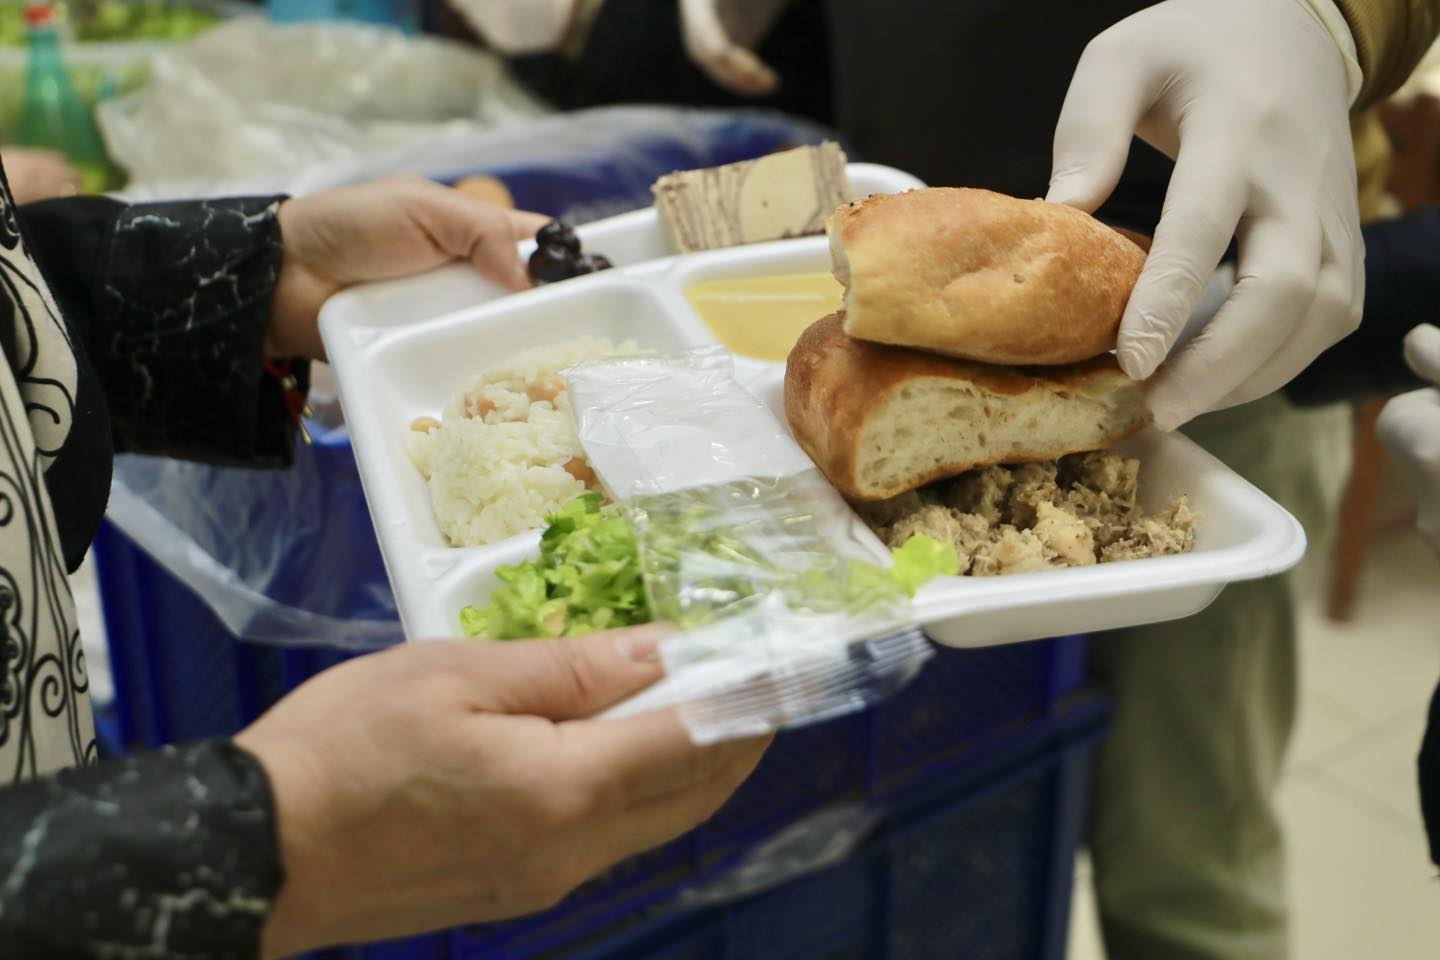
825;187;1145;364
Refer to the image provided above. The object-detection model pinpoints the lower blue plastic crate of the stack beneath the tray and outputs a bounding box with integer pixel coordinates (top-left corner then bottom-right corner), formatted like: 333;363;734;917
455;697;1106;960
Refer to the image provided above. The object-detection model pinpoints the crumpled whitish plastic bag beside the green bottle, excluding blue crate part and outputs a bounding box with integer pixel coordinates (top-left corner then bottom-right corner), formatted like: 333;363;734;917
98;17;546;183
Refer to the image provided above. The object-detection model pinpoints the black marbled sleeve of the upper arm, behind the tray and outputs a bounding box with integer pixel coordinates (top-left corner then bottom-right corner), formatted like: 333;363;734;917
20;197;308;466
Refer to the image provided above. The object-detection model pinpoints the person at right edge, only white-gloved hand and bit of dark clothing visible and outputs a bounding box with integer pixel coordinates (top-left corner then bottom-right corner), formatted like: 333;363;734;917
1375;322;1440;866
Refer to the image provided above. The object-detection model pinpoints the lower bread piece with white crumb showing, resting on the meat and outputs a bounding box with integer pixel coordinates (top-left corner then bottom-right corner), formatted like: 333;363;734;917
785;314;1146;499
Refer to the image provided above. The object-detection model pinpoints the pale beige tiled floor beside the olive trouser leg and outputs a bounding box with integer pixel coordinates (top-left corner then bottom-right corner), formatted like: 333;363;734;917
1070;515;1440;960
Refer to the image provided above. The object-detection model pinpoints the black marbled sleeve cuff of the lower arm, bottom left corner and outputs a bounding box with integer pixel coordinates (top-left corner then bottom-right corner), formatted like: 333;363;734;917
0;741;284;960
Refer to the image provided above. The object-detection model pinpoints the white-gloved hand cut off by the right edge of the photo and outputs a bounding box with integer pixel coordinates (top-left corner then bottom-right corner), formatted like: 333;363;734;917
1375;325;1440;553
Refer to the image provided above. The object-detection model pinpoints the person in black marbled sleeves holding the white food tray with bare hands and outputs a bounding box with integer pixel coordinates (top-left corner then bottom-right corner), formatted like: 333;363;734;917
0;174;765;959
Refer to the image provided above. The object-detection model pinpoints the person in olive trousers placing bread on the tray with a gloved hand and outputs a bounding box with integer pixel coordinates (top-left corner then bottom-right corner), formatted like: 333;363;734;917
454;0;1440;960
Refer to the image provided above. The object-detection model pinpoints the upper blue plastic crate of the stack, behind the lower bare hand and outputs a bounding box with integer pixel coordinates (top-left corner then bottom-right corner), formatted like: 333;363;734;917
96;500;1084;960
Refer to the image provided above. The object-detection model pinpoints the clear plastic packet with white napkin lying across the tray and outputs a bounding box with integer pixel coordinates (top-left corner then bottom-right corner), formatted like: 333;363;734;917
567;347;930;743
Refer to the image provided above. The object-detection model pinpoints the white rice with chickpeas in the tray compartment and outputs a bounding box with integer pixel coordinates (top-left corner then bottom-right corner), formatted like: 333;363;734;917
406;337;638;547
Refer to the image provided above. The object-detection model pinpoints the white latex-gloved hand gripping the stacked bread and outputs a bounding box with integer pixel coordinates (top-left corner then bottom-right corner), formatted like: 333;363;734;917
1047;0;1365;430
